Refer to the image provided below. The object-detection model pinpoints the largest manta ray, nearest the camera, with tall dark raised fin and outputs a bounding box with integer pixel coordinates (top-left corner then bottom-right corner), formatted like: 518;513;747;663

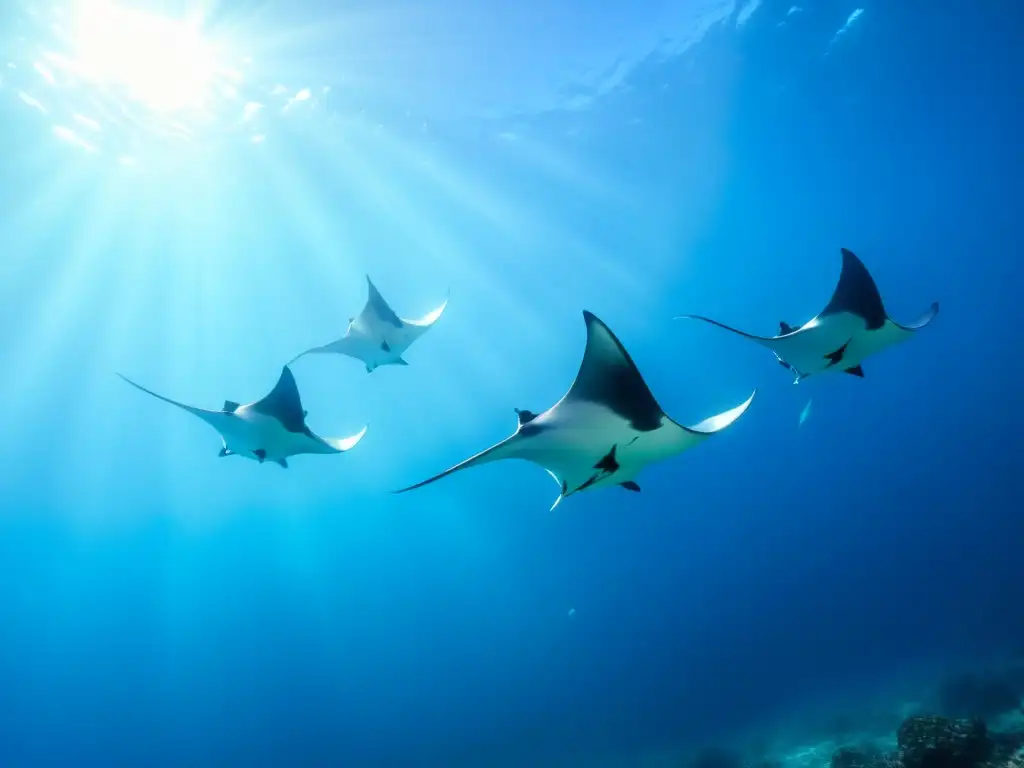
395;311;756;510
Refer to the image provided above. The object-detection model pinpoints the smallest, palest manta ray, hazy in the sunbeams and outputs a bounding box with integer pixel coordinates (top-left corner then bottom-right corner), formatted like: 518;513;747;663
289;275;449;374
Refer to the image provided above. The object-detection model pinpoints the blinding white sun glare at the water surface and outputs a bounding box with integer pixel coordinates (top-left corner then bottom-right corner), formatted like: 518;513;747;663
69;0;220;113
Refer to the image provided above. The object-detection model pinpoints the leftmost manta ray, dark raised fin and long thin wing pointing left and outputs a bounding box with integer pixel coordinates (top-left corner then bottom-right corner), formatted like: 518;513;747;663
118;366;367;469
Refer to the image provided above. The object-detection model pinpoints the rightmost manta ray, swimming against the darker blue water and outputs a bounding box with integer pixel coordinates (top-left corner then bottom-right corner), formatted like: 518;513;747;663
677;248;939;384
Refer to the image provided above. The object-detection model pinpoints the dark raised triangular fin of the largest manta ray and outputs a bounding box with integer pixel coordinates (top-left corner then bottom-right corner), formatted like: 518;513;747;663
566;310;665;432
